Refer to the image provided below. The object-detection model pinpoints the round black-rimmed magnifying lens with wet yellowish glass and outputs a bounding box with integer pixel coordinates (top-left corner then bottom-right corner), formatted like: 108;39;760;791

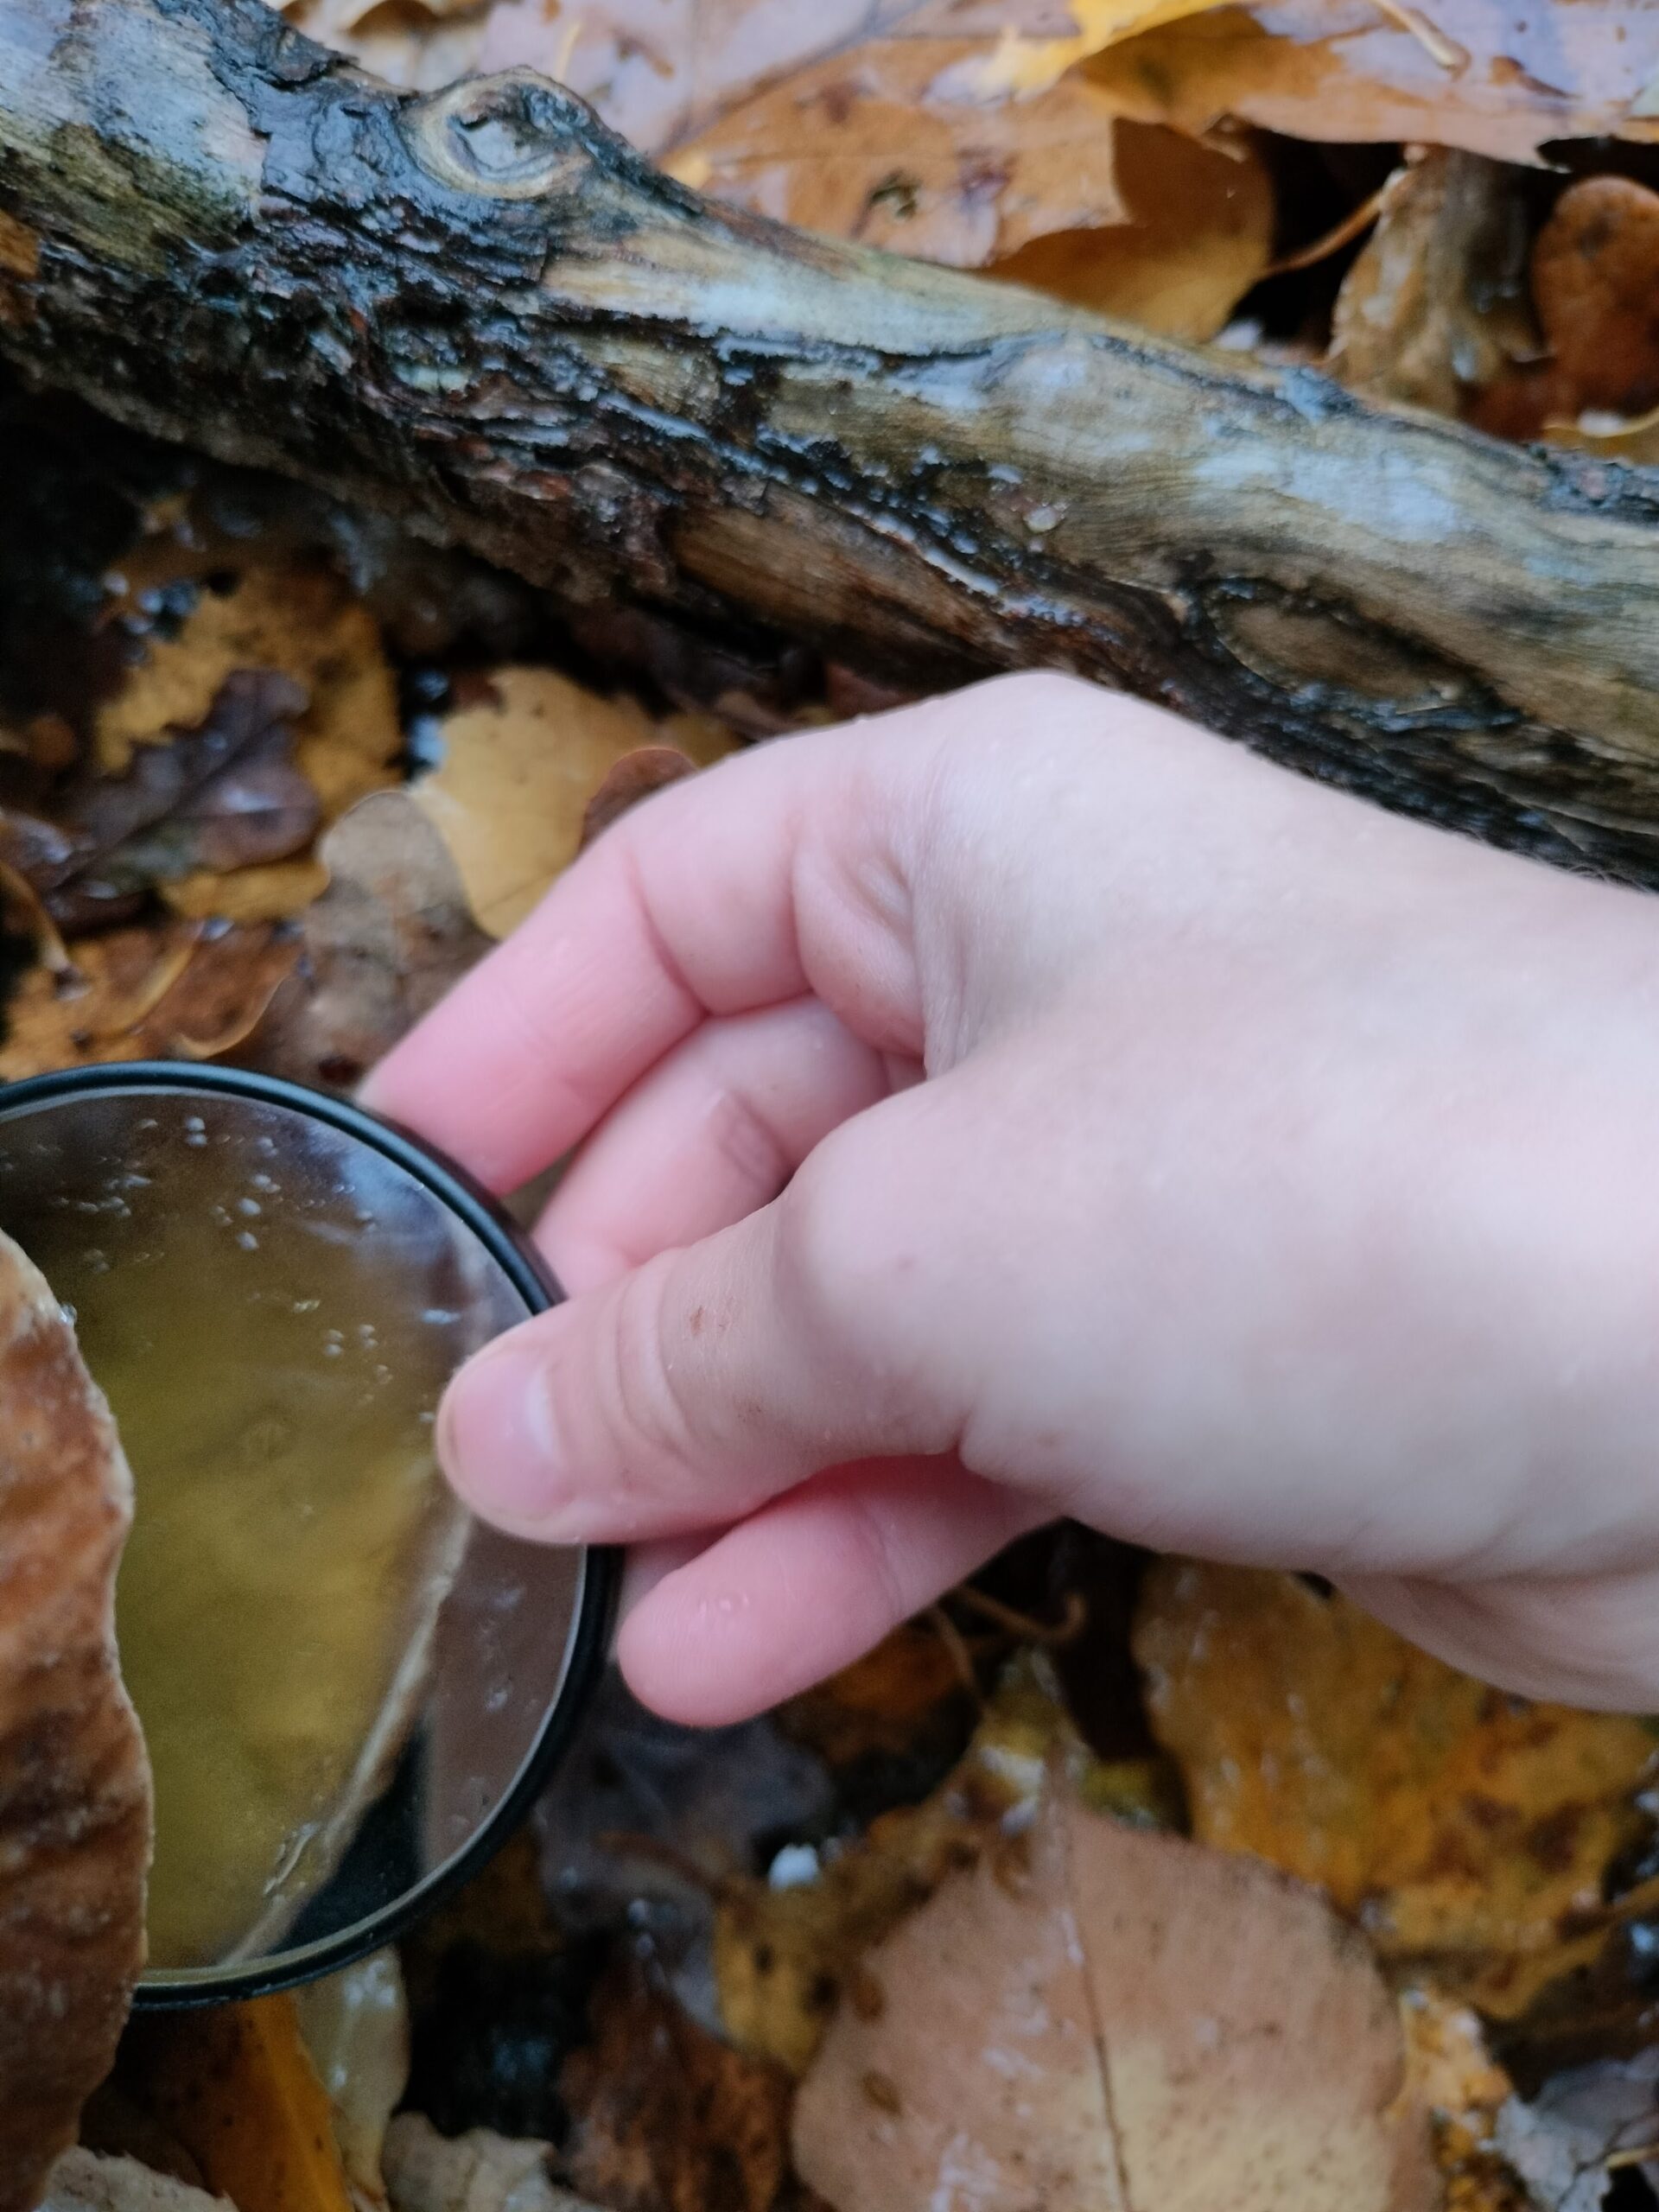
0;1062;617;2006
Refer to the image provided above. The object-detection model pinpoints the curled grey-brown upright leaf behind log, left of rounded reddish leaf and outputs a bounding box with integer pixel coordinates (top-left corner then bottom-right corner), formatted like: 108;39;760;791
1327;146;1537;416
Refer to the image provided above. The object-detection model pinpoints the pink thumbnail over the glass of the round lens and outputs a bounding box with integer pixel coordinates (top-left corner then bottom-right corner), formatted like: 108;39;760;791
438;1336;566;1533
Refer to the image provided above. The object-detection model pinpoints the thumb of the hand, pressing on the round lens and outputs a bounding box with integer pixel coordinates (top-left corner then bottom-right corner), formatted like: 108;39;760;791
438;1093;964;1544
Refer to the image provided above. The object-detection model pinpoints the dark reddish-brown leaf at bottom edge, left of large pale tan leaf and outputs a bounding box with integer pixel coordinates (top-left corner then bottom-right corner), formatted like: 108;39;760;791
560;1960;794;2212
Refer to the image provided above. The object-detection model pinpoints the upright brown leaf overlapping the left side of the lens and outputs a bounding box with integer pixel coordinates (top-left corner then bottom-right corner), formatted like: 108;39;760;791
0;1234;150;2212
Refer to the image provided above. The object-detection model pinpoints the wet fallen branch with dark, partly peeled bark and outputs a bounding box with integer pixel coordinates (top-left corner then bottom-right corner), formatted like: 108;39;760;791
0;0;1659;885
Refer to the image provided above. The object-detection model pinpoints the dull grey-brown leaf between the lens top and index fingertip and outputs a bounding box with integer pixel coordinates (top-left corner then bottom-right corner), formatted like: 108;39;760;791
238;791;491;1089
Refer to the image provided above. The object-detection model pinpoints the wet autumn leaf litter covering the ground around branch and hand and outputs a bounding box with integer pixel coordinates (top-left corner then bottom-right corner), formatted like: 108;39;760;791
16;0;1659;2212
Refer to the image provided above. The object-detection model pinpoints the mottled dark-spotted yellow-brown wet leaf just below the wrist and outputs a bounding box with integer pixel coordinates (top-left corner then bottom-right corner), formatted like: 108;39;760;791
1135;1561;1659;2019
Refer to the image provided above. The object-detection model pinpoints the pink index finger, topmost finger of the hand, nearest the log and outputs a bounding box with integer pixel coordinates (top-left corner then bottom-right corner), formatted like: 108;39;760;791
363;708;936;1190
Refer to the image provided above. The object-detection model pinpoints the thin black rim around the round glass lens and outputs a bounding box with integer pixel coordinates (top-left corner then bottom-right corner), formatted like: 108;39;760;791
0;1059;621;2013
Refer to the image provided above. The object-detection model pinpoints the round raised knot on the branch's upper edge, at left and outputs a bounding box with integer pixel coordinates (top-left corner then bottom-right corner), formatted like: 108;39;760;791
403;68;588;199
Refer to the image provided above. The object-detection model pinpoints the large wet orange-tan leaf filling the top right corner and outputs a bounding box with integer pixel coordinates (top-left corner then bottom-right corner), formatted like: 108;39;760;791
1084;0;1659;162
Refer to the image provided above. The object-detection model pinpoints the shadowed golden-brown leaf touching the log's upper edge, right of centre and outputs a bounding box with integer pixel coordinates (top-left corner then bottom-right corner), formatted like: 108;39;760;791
988;124;1274;339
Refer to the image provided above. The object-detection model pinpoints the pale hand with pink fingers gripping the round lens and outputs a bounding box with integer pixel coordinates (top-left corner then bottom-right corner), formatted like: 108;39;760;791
370;677;1659;1721
